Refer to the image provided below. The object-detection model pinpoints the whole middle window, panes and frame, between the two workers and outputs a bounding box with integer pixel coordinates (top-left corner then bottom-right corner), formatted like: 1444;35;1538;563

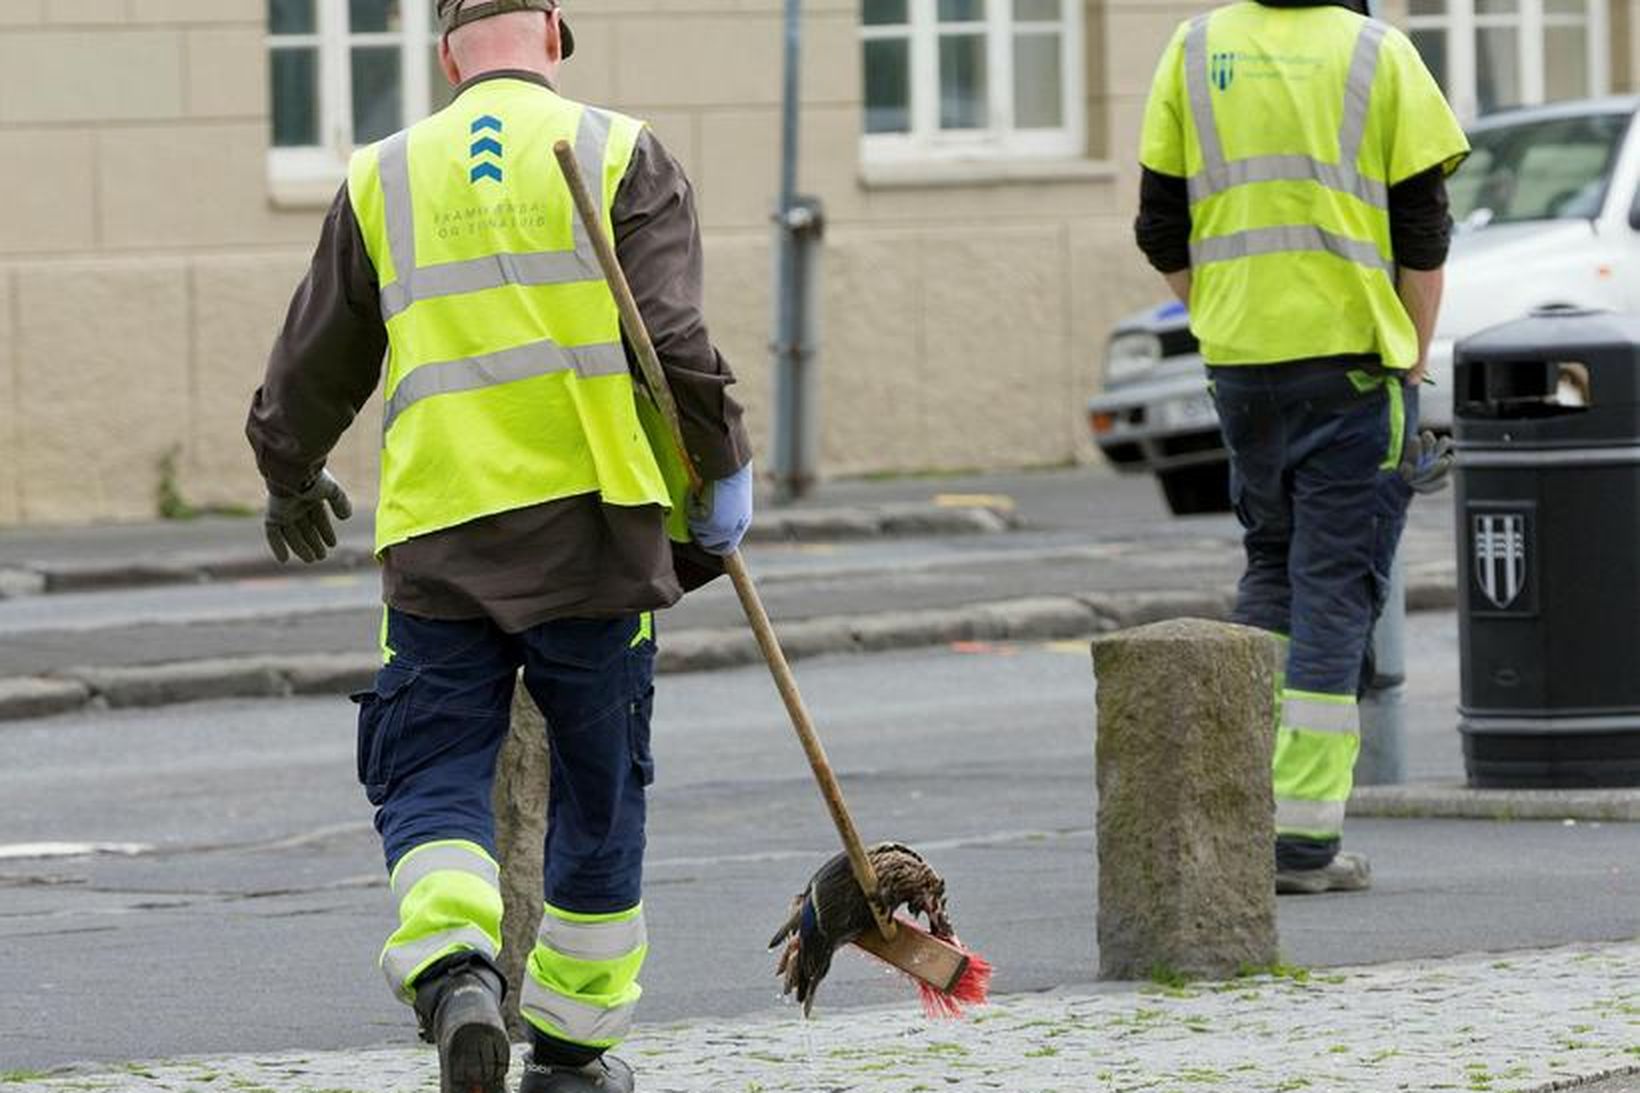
861;0;1086;161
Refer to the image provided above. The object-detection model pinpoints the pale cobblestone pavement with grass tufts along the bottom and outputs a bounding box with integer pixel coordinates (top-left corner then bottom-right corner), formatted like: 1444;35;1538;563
15;940;1640;1093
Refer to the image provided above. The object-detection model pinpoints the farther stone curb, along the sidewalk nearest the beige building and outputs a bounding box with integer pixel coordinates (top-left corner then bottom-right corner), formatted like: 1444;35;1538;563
0;504;1020;599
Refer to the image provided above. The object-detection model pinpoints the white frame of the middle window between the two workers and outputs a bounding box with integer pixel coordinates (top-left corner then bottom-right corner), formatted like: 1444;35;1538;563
859;0;1087;164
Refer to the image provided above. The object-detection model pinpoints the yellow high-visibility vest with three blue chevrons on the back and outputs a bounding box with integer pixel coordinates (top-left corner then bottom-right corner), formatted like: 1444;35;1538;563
348;77;687;553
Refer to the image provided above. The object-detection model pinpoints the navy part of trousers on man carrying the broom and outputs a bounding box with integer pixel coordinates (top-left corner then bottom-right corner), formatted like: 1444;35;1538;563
354;611;654;914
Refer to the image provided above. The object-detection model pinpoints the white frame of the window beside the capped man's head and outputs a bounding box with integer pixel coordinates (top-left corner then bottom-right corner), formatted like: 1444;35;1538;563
264;0;444;192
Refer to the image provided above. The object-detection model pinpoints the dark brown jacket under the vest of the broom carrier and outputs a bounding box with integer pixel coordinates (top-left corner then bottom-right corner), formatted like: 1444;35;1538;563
246;71;751;632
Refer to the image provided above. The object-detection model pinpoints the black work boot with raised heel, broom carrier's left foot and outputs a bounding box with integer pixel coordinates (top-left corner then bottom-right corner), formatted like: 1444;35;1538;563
415;954;512;1093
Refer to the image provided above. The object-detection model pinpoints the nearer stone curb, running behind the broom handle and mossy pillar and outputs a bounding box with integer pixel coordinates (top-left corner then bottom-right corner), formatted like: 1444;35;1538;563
0;581;1482;722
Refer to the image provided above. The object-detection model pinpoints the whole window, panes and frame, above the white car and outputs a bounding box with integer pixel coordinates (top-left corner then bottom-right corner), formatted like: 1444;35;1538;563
1407;0;1607;120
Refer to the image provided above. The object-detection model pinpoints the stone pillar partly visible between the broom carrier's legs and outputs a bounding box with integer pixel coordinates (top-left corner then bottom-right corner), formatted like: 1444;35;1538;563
492;676;548;1040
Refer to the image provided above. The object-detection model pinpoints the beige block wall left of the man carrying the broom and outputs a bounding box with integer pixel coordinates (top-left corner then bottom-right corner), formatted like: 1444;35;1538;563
0;0;326;524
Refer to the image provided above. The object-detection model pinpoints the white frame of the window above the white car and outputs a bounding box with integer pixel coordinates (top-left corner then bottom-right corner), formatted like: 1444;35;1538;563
1407;0;1610;121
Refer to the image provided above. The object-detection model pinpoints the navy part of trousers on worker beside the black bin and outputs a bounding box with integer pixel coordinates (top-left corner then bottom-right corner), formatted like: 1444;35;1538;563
1209;359;1417;694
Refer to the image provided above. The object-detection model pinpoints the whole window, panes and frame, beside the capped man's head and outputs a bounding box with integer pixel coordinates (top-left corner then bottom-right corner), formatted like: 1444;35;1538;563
267;0;451;184
